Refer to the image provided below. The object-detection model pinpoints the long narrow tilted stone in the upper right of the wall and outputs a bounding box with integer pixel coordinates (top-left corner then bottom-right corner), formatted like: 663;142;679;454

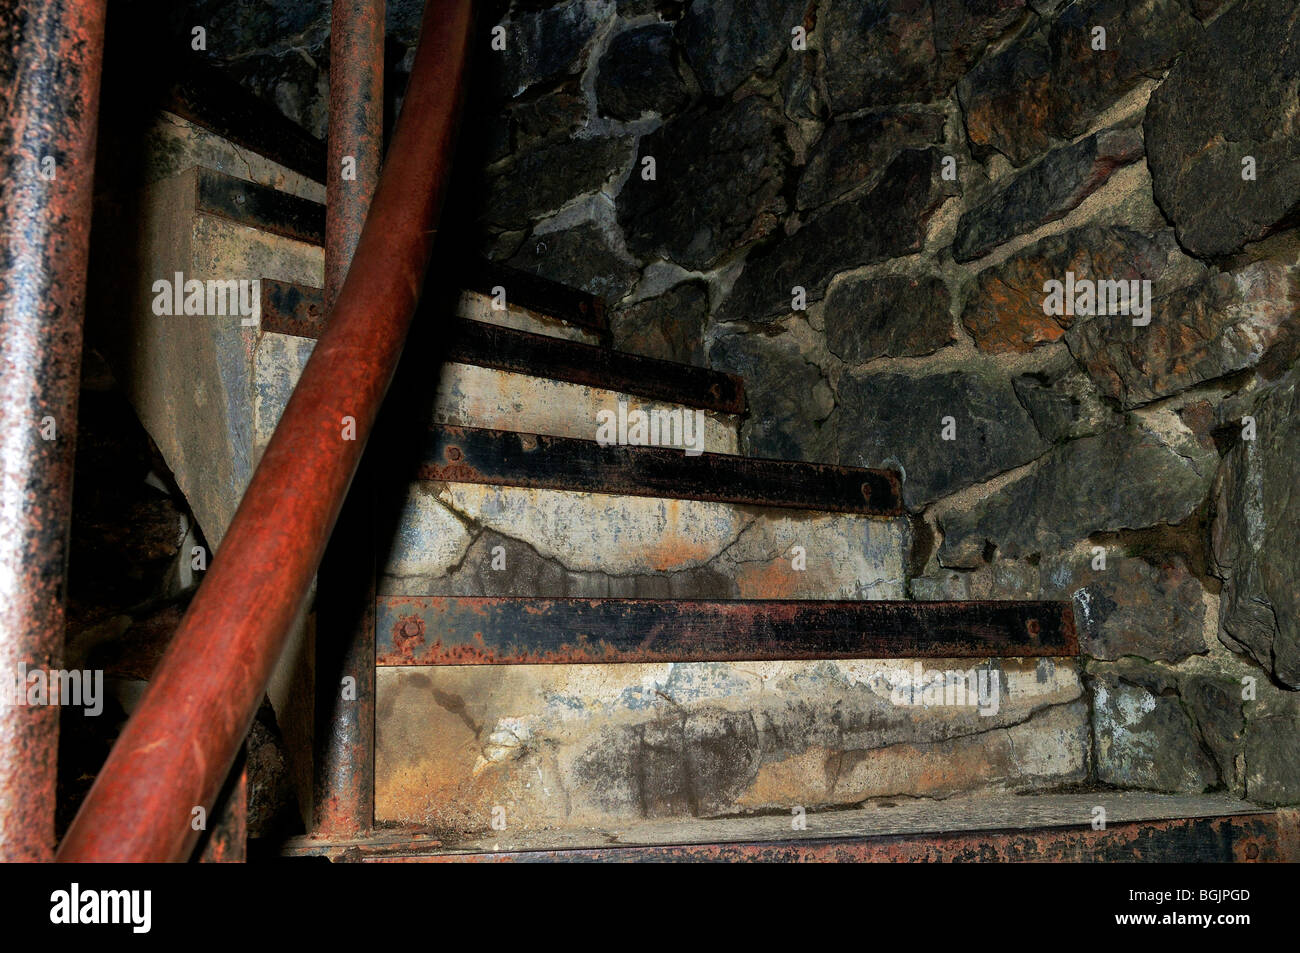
953;129;1143;261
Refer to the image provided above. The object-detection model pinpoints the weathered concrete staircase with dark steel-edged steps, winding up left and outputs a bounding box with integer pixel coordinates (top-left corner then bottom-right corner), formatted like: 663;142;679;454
117;100;1294;859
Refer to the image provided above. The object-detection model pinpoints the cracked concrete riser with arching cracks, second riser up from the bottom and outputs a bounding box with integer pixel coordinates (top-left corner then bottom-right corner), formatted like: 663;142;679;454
381;482;911;599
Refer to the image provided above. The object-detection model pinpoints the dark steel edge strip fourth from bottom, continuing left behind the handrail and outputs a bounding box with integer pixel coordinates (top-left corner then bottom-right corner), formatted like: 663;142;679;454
260;278;745;415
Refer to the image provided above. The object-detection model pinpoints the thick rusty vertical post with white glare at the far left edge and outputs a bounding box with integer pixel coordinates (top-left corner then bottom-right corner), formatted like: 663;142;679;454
0;0;104;861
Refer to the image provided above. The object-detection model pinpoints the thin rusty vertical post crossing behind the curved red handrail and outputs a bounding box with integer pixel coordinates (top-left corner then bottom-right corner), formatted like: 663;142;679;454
312;0;384;837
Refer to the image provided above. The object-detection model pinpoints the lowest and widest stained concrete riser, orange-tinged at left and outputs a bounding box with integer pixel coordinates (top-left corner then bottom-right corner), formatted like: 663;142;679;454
376;659;1089;831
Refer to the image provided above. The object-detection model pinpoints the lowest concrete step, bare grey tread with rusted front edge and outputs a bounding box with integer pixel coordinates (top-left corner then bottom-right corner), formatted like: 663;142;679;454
283;790;1300;863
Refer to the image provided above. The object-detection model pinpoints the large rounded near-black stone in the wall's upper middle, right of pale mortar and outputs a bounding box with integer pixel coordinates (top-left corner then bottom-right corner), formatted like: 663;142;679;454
618;96;789;269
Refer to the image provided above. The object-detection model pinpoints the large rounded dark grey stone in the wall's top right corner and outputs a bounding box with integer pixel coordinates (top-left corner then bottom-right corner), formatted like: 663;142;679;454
1147;0;1300;256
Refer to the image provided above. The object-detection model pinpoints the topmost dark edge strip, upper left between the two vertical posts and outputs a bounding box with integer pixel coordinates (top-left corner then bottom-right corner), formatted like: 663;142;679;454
160;56;325;182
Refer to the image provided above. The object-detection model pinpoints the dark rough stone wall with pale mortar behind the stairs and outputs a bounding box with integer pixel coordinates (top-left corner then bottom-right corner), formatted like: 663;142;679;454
198;0;1300;803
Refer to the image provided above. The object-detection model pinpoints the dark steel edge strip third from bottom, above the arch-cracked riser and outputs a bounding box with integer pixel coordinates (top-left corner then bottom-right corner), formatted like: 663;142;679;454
416;423;905;516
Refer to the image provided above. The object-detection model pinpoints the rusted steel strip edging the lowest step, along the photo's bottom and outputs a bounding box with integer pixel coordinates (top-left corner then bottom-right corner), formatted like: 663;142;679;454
387;813;1300;863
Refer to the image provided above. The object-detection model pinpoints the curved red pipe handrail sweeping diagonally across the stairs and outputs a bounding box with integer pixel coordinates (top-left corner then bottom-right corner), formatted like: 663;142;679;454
56;0;472;862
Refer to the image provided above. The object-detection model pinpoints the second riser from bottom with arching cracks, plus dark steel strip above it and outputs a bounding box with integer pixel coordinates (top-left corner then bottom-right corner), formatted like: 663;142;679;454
380;428;911;599
